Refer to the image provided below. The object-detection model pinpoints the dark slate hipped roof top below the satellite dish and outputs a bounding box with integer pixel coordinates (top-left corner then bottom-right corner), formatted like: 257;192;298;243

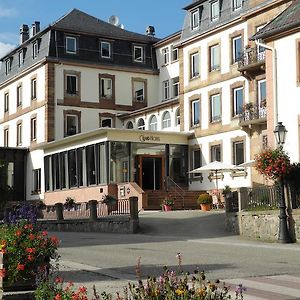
52;9;159;43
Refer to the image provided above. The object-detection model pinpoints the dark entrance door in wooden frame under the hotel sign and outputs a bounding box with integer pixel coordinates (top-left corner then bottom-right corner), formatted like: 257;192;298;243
139;156;164;190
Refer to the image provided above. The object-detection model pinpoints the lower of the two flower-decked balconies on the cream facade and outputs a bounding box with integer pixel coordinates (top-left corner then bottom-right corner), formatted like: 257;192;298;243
239;103;267;127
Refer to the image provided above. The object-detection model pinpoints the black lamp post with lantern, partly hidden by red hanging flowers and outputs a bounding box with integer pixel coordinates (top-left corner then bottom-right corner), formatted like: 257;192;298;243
274;122;292;243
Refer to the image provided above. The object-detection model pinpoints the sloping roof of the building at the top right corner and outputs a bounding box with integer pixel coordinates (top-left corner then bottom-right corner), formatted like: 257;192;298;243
251;0;300;40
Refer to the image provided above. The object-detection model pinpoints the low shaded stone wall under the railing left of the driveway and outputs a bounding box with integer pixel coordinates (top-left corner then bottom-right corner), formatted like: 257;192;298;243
39;216;139;233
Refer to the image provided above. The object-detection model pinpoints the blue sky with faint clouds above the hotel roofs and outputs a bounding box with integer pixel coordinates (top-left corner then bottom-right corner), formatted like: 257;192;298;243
0;0;192;57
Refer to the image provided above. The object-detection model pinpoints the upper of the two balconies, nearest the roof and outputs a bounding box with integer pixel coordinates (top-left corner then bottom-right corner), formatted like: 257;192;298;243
238;47;266;79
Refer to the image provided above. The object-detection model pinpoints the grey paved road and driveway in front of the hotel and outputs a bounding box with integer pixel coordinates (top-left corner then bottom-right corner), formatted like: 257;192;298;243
51;211;300;299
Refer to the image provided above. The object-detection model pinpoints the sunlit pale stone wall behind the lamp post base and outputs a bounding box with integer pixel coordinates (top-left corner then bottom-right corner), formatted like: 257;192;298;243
225;209;300;241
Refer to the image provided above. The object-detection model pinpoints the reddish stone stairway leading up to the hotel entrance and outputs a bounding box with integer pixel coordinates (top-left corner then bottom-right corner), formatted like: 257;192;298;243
144;190;202;210
